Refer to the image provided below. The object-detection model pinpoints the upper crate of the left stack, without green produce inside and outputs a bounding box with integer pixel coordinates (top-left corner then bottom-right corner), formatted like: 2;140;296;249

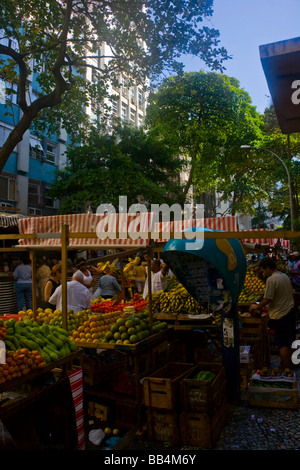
143;362;193;410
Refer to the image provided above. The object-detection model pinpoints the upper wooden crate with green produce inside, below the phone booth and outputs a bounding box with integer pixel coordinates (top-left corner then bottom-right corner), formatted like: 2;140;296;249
180;363;226;413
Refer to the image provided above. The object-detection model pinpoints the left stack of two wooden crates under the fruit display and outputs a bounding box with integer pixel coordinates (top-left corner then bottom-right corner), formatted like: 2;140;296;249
143;362;194;444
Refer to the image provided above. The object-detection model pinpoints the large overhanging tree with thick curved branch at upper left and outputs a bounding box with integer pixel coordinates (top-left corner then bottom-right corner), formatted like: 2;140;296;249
0;0;228;171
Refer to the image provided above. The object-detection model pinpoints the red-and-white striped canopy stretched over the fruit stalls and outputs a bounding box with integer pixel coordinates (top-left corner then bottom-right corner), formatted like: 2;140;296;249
19;212;289;249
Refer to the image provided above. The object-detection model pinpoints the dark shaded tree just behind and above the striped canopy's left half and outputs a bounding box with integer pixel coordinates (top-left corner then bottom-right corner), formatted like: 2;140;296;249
49;127;182;213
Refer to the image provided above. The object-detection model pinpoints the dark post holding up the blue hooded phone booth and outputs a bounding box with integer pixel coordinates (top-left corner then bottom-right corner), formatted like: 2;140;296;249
222;302;240;402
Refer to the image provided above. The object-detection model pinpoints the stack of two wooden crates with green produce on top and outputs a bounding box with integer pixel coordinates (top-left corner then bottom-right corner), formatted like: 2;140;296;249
180;363;228;449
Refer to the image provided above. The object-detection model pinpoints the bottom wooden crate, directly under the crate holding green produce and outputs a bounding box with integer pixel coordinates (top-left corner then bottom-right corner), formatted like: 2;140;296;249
179;399;228;449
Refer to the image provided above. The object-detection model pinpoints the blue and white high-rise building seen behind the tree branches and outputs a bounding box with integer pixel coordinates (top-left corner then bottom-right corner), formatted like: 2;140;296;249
0;35;147;216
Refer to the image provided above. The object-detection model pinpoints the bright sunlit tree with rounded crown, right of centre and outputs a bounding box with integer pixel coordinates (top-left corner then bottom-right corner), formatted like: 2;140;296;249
146;72;262;212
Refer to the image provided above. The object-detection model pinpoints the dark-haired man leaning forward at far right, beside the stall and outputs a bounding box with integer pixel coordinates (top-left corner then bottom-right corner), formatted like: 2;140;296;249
249;257;296;370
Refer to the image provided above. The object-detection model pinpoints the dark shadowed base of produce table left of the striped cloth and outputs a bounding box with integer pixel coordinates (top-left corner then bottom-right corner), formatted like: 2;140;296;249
0;350;82;450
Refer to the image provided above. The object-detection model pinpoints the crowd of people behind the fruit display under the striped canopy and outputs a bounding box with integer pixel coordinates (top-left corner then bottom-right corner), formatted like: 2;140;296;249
1;255;169;312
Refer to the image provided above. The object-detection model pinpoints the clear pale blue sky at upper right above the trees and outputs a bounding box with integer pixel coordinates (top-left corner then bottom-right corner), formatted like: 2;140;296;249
184;0;300;113
